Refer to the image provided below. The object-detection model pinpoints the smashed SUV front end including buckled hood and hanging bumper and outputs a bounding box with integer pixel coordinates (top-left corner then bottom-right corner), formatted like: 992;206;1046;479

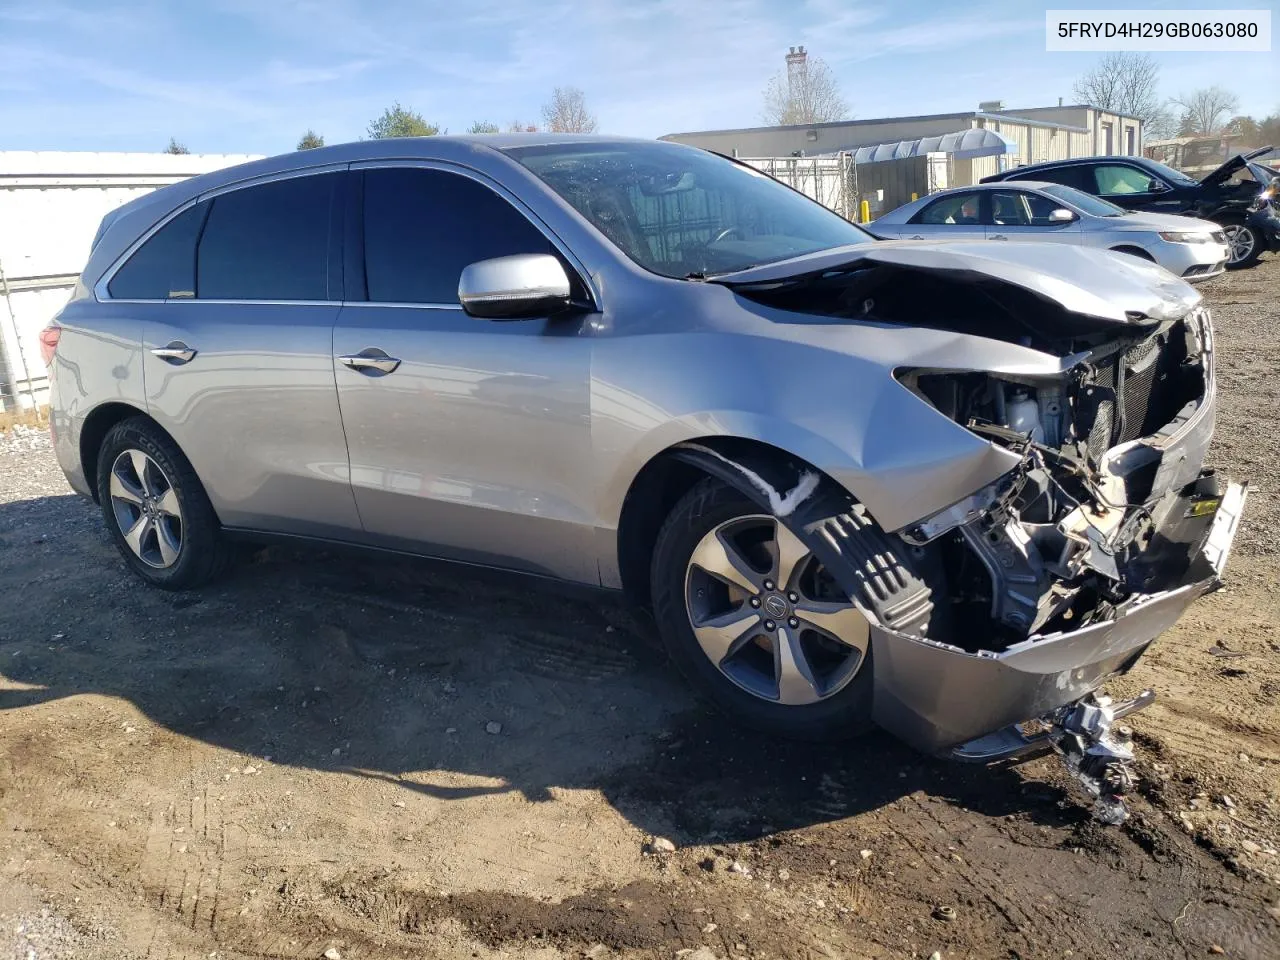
716;244;1247;822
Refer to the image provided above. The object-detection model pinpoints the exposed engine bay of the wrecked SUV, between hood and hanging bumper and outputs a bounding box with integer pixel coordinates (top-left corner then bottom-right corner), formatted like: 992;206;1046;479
899;311;1220;652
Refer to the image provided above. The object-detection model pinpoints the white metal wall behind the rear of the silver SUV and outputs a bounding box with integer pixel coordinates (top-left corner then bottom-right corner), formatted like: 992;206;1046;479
0;151;257;410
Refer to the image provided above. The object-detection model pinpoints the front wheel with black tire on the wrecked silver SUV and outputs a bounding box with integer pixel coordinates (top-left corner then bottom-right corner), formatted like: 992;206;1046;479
652;479;872;740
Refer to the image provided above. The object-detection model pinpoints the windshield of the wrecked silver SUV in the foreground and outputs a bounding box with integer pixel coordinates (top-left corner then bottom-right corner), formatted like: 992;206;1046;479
506;142;873;278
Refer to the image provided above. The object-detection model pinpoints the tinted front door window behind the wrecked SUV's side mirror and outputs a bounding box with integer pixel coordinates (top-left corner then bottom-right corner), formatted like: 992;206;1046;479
365;168;553;303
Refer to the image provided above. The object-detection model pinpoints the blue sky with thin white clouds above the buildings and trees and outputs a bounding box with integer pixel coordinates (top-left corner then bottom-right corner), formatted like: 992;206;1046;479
0;0;1280;154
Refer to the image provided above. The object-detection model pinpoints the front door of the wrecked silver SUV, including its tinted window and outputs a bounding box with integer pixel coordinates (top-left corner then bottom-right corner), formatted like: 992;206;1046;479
333;164;598;582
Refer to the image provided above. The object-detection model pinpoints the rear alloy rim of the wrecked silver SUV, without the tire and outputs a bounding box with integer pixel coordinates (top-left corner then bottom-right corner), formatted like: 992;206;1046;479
109;449;183;570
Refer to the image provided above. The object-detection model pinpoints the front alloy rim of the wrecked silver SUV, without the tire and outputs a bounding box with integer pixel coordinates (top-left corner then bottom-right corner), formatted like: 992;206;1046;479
685;515;870;707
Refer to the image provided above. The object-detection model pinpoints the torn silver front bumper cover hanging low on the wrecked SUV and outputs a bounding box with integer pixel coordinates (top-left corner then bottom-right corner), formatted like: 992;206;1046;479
872;484;1247;753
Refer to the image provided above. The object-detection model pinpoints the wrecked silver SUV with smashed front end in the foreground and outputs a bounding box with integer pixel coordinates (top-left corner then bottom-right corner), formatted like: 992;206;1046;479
46;136;1243;798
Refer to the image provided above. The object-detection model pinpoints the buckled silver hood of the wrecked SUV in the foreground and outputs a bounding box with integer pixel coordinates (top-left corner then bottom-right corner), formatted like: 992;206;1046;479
710;239;1201;329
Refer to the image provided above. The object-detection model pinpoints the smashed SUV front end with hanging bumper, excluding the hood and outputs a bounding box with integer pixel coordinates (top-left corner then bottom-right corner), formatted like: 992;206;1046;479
876;307;1245;820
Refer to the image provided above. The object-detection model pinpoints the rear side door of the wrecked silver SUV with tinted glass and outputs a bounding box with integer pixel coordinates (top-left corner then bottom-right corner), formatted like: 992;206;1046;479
119;169;360;536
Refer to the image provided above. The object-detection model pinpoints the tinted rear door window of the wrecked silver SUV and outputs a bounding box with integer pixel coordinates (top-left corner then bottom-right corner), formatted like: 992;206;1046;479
197;173;340;300
